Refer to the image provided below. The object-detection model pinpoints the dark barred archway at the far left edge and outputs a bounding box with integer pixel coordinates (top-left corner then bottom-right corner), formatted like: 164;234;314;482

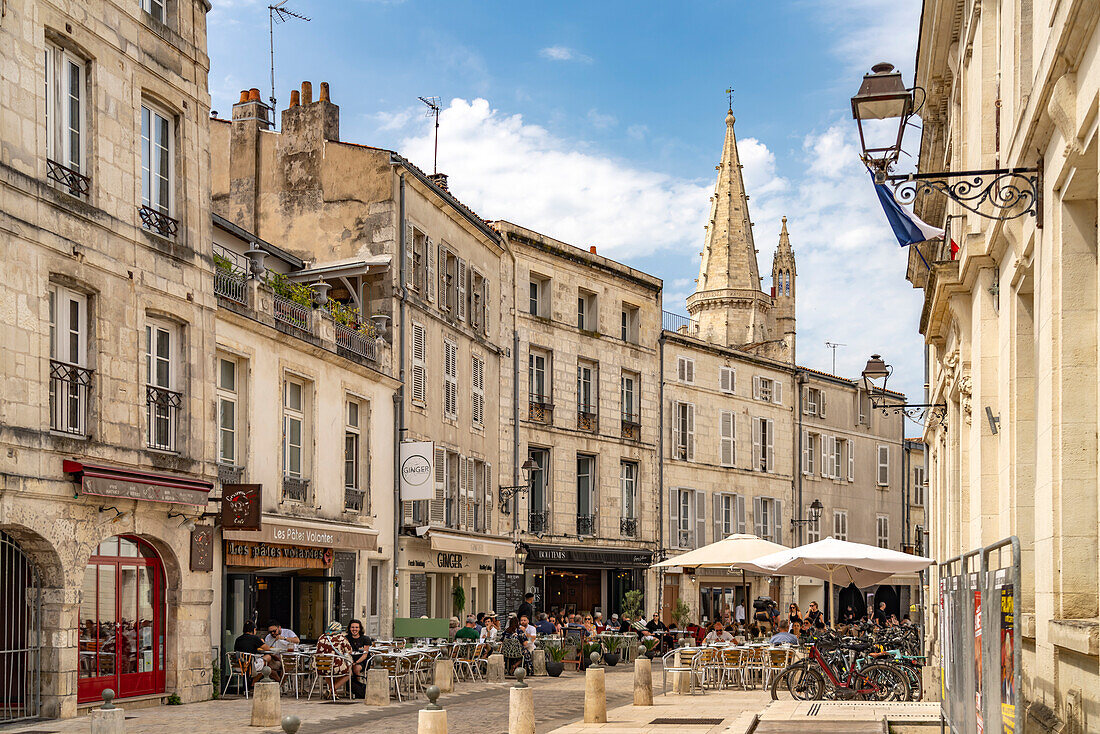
0;530;42;724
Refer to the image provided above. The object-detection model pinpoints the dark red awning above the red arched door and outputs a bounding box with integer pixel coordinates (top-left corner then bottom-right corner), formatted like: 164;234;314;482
62;459;213;507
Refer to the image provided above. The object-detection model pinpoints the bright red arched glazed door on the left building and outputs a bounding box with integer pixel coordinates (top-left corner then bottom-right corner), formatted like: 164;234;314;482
77;535;165;702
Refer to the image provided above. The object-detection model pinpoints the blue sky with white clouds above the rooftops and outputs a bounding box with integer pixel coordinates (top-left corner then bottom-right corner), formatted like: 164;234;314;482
208;0;923;407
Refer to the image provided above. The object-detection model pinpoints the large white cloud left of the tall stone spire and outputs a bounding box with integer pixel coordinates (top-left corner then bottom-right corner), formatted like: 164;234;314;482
400;99;711;259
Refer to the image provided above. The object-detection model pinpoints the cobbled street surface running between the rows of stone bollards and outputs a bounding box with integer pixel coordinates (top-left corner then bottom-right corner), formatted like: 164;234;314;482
8;665;748;734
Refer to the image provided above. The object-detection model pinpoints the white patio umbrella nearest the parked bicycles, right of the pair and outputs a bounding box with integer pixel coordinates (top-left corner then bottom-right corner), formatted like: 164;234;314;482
741;536;933;588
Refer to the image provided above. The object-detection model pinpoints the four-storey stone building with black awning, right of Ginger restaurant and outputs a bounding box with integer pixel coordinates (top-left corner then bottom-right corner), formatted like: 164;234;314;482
494;221;662;616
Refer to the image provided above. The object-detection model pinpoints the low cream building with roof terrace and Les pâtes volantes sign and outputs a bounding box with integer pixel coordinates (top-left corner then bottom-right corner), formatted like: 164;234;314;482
210;216;398;649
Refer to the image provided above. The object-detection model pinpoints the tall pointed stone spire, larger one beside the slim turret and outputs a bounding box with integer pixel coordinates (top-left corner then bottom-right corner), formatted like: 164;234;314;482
688;110;773;347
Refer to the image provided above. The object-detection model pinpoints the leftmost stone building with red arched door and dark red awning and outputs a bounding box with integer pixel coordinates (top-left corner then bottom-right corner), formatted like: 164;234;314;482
0;0;217;722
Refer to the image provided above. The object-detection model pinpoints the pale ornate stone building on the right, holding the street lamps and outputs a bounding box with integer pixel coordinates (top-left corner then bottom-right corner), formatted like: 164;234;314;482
908;0;1100;732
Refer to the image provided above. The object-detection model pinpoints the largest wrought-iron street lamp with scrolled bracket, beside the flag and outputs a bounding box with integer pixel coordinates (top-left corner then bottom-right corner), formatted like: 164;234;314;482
851;63;1043;227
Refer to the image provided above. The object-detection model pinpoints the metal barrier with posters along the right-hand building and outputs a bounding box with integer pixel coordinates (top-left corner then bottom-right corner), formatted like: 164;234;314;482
939;536;1024;734
